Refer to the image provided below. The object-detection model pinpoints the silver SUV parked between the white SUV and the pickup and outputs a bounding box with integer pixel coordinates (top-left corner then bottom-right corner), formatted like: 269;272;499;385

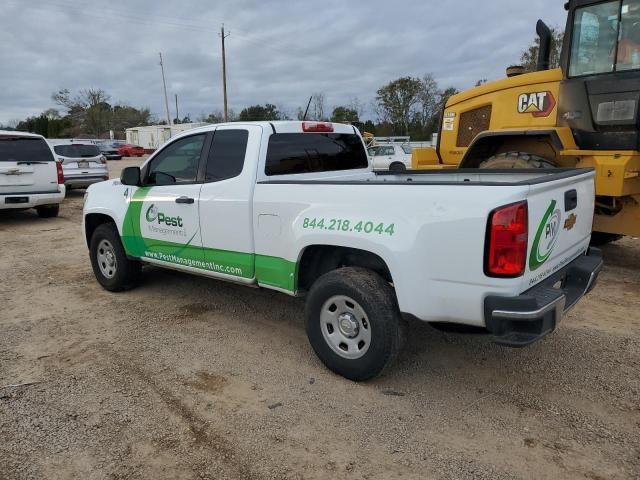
49;140;109;190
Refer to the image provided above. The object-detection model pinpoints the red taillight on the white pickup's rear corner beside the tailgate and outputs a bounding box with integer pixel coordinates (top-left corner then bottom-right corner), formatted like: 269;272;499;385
485;202;529;277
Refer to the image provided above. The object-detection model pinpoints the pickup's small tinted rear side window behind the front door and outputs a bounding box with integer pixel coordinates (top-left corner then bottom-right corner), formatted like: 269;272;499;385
205;130;249;182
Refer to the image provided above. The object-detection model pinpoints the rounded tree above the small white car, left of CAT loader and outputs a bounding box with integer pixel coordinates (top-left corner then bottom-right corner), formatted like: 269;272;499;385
376;77;423;135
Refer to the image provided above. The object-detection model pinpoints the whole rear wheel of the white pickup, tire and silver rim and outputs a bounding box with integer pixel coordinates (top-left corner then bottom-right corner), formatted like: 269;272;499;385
305;267;405;381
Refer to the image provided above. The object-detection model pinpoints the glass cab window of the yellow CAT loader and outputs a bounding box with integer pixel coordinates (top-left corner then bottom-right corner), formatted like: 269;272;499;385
569;0;640;77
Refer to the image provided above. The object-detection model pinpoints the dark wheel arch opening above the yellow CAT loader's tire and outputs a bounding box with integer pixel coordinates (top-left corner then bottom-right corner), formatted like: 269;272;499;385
459;130;564;168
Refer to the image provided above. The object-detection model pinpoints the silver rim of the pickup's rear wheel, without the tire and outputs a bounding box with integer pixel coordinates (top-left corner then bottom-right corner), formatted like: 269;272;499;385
320;295;371;360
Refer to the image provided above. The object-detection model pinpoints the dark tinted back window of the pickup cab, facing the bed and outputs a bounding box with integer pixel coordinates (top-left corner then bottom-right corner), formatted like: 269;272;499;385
265;133;369;175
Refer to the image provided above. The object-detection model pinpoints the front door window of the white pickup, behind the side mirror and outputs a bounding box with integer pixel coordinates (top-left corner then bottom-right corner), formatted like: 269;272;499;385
145;134;206;185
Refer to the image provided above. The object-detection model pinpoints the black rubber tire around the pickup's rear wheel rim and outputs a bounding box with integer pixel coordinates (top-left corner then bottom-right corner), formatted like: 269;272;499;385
305;267;406;381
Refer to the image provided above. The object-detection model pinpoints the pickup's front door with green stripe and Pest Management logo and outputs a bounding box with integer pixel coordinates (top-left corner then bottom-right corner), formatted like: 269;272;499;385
123;133;207;268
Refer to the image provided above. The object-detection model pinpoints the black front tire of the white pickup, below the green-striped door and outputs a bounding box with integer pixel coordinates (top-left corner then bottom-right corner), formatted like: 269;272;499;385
89;223;142;292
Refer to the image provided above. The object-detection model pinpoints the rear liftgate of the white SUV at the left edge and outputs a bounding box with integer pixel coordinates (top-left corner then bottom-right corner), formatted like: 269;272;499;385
0;134;58;195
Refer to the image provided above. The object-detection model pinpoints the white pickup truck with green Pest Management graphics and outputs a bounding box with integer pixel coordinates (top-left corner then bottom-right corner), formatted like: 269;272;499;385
83;122;602;380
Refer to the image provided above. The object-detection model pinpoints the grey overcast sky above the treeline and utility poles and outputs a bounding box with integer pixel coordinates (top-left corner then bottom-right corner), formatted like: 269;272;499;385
0;0;565;124
